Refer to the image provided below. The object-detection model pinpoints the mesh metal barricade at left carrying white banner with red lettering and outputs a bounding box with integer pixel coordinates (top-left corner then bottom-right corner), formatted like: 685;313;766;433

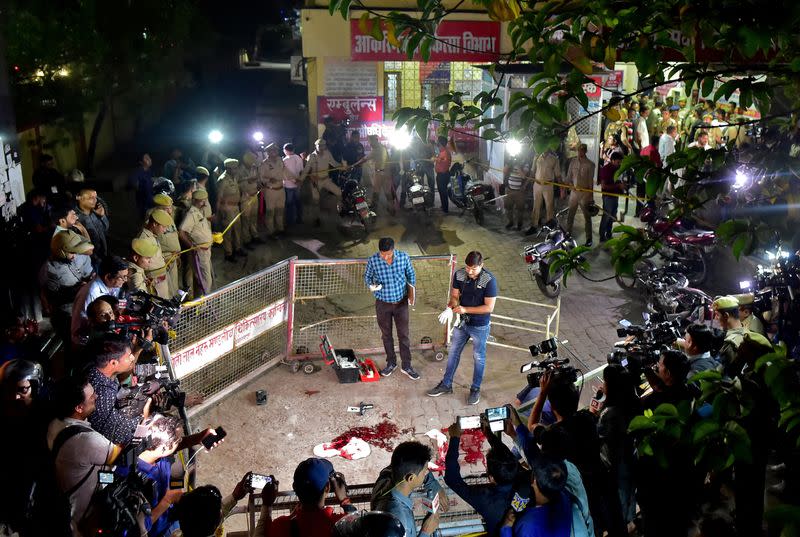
170;260;291;414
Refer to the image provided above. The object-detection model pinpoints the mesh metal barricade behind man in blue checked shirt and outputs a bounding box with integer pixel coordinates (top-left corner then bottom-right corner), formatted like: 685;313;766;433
286;255;455;358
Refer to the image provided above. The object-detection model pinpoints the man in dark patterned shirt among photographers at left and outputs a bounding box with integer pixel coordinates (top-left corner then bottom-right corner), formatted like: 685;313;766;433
87;333;151;446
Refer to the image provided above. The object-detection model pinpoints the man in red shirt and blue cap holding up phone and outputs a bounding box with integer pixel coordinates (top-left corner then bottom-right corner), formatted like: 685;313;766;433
254;457;356;537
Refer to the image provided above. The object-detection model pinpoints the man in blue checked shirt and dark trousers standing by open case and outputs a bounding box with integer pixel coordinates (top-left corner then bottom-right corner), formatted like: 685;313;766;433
364;237;420;380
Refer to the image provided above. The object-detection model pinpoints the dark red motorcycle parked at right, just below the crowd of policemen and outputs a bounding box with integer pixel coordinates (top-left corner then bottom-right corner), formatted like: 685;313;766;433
616;200;716;289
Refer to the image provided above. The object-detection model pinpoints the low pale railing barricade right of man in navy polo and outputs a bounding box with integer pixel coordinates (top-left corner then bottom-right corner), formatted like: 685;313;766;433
486;296;561;354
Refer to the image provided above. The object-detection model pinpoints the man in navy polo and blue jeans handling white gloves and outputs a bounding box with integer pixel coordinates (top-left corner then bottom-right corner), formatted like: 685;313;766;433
428;251;497;405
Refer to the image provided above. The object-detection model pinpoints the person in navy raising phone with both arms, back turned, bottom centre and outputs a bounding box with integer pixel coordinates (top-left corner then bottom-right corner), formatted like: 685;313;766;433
444;419;519;535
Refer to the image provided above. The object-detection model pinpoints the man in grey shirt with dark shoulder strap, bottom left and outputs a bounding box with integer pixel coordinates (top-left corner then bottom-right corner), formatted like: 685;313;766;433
47;377;121;531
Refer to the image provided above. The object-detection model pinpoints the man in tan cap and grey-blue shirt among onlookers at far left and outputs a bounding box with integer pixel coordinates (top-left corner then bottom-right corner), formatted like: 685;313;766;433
39;231;94;341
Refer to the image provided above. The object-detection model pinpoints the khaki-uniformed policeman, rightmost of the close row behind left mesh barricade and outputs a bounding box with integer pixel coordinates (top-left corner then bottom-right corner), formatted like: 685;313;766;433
178;190;213;296
